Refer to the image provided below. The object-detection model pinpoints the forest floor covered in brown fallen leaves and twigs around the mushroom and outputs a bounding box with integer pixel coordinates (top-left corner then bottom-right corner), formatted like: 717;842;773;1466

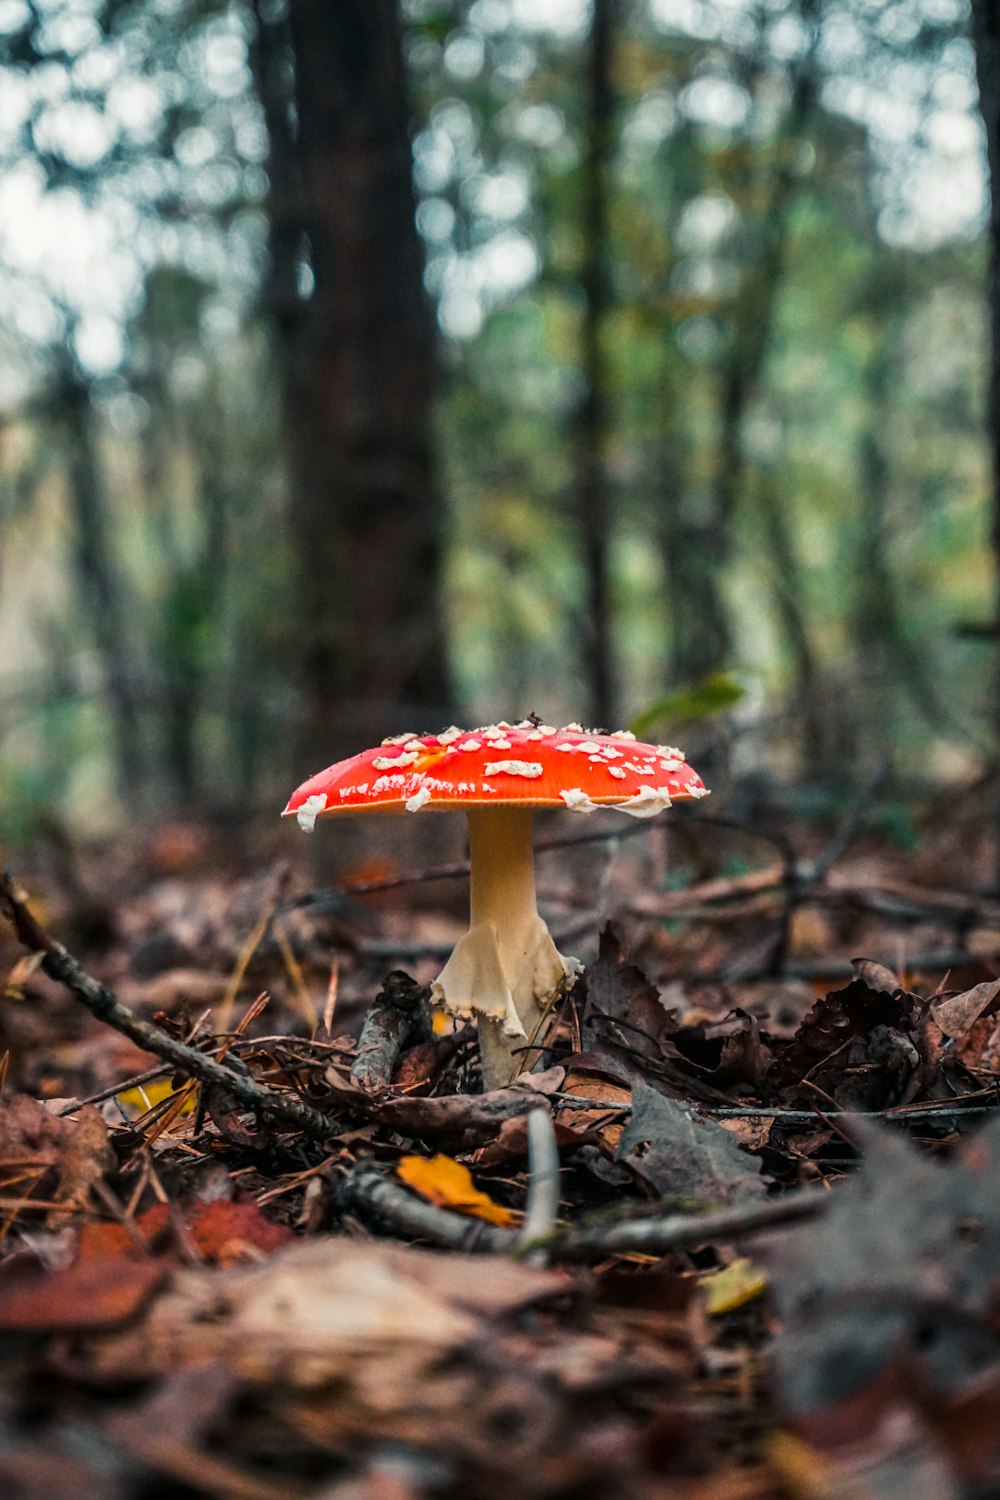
0;786;1000;1500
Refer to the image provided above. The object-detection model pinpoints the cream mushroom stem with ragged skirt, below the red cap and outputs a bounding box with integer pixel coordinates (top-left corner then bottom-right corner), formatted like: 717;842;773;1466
433;807;579;1089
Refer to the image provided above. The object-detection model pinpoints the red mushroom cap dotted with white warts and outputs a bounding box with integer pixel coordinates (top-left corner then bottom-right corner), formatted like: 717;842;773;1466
282;720;706;828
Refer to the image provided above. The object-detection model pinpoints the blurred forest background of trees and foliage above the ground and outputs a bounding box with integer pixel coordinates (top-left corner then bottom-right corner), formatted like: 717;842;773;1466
0;0;1000;858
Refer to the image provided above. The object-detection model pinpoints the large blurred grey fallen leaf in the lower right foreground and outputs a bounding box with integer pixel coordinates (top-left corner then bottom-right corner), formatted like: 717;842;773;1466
757;1119;1000;1478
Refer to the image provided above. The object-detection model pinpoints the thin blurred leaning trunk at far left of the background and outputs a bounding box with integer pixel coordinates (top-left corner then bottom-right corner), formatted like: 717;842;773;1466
57;360;148;810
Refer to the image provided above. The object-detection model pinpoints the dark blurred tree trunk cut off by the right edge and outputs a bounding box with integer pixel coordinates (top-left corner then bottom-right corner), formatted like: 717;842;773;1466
972;0;1000;786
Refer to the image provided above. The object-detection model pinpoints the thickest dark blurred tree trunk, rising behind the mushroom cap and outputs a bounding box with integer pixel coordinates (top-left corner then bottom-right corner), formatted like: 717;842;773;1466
255;0;450;761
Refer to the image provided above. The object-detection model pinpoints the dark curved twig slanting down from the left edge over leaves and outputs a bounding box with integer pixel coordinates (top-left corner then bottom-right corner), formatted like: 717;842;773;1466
0;870;337;1140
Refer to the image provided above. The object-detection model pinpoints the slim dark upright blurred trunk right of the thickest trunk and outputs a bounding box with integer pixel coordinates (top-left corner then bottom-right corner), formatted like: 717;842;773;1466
576;0;618;729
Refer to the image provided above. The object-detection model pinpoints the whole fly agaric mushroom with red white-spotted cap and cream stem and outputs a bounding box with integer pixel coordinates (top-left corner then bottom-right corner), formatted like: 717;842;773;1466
283;720;706;1089
